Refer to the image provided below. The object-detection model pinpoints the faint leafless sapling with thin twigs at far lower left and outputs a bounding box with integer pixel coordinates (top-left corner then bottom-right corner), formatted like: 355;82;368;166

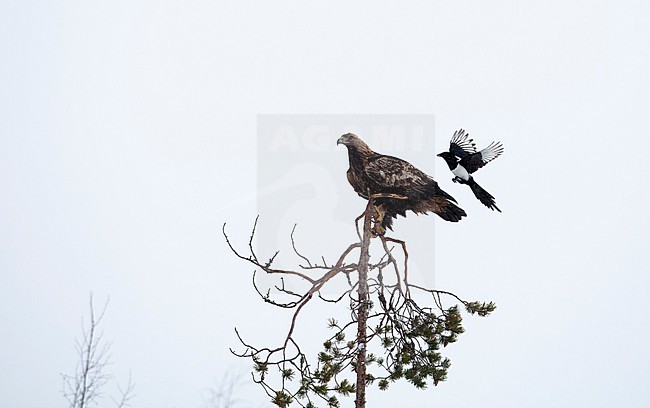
61;293;135;408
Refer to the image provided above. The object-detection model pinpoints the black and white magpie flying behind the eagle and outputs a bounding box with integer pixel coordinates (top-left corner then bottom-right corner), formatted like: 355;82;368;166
438;129;503;212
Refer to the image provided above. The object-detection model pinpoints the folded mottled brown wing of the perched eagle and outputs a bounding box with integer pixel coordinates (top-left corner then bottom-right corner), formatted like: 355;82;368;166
365;155;431;192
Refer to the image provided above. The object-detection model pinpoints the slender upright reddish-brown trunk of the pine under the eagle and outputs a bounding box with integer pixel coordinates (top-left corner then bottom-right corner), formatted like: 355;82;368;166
355;202;374;408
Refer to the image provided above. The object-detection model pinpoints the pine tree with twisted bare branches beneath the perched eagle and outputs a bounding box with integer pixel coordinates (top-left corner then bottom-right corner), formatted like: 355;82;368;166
222;194;496;408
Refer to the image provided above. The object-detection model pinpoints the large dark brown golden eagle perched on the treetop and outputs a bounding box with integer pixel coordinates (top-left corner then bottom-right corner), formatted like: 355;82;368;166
336;133;467;235
